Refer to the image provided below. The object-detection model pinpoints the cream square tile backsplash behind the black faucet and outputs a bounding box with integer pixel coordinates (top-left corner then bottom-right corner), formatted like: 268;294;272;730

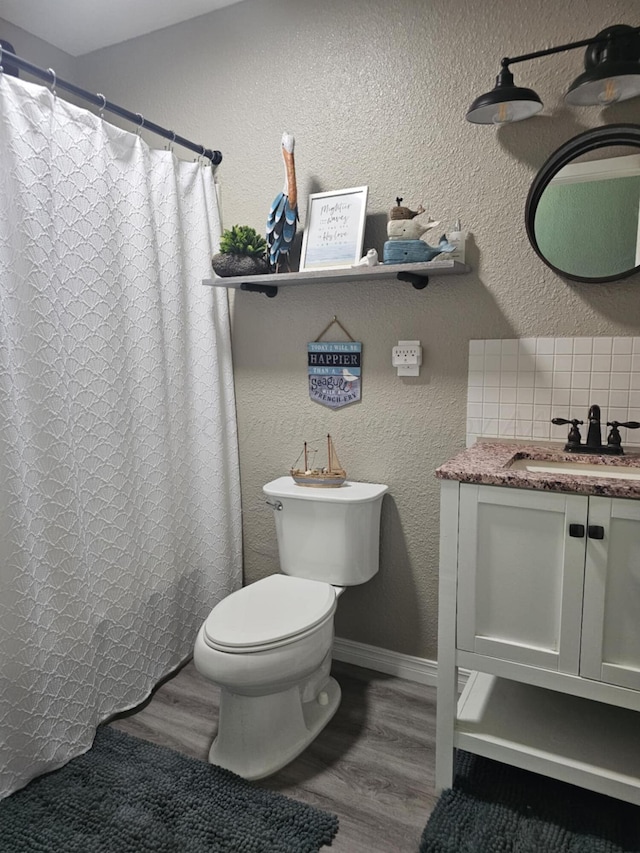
467;337;640;447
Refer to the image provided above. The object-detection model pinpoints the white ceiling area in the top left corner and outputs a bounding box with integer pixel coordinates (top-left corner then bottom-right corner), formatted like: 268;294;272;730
0;0;248;56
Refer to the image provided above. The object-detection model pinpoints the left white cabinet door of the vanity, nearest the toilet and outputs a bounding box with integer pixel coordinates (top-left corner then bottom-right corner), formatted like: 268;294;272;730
457;484;588;674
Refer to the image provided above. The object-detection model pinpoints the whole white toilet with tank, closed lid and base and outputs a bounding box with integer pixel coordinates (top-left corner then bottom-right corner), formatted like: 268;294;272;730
193;477;387;779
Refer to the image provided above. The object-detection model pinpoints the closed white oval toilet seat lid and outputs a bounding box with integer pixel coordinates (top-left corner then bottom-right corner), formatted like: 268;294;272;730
203;575;336;654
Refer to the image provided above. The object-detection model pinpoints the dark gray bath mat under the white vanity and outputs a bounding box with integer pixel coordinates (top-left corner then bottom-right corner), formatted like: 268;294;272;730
420;752;640;853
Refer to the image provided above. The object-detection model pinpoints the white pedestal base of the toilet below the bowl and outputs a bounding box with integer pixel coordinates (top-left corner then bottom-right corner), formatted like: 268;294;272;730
209;676;341;779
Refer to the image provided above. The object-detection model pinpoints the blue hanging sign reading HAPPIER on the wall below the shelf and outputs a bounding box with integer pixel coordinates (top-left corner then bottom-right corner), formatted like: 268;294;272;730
307;341;362;409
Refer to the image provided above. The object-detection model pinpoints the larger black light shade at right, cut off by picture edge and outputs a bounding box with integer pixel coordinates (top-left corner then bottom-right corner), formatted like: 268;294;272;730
565;24;640;107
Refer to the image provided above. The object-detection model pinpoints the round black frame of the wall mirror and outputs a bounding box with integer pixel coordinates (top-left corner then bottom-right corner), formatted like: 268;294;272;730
525;124;640;283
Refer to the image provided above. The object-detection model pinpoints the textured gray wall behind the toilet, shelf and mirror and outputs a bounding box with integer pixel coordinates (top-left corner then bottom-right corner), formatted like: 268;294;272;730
5;0;640;658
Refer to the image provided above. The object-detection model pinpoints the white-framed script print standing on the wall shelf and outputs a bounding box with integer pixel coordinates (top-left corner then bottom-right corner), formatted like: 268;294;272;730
300;187;369;272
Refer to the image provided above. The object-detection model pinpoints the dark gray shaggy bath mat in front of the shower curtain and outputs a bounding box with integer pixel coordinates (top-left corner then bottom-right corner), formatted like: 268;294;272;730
0;726;338;853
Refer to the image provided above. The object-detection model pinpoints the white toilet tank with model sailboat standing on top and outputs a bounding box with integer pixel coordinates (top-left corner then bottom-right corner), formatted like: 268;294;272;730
263;477;387;586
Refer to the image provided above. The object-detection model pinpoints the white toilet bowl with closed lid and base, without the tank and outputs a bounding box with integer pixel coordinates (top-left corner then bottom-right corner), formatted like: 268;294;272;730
194;575;342;779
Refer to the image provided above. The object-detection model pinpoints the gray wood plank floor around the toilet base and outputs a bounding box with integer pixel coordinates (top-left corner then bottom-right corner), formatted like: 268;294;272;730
109;662;436;853
